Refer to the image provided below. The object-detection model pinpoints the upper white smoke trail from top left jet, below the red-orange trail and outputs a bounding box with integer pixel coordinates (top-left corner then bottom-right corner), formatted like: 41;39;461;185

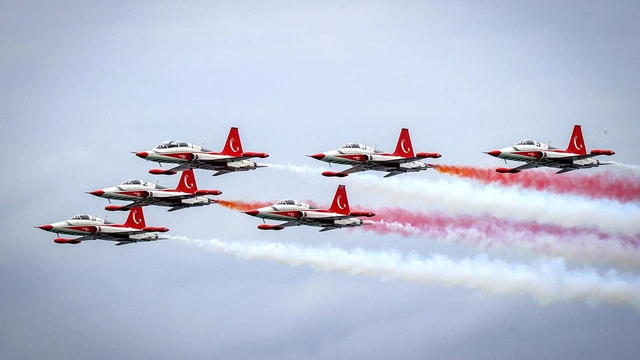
274;164;640;235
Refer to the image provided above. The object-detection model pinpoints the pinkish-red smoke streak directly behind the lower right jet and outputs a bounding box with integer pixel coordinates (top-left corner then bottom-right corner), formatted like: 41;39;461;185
363;208;640;250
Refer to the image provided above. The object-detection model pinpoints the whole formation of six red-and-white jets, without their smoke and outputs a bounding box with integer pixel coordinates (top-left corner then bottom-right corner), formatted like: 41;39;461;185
37;125;615;245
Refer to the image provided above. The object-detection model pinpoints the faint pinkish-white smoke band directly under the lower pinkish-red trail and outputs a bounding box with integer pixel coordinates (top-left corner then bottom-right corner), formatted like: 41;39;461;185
372;220;640;269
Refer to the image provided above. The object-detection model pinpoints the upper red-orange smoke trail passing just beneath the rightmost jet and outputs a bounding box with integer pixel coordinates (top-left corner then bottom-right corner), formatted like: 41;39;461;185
433;165;640;202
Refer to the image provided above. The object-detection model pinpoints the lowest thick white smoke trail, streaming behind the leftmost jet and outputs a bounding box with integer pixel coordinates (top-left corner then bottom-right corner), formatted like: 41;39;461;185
173;237;640;311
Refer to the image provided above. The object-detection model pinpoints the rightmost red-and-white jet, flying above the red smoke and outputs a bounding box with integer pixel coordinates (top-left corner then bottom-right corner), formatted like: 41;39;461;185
485;125;615;174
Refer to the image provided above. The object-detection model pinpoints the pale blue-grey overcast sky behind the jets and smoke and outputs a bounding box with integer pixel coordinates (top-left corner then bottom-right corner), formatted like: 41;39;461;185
0;1;640;359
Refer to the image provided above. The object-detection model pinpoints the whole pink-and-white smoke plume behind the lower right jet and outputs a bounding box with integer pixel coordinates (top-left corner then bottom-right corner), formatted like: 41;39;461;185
362;208;640;268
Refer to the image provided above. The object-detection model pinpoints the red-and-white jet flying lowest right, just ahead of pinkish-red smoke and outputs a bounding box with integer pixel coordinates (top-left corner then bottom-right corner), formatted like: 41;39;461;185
244;185;375;231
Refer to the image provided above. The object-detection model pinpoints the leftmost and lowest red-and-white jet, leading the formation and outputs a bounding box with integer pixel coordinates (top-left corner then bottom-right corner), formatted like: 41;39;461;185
37;207;169;245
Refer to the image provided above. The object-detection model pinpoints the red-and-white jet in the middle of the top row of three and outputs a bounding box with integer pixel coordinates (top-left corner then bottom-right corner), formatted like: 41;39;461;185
307;128;442;177
